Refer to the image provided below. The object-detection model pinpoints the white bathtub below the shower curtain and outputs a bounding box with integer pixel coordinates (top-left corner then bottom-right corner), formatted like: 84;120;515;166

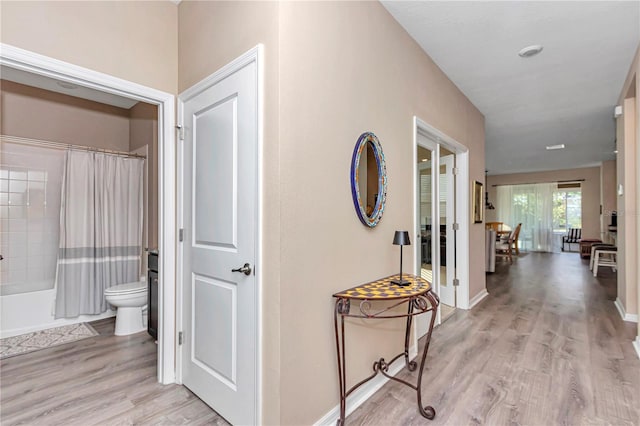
0;289;116;338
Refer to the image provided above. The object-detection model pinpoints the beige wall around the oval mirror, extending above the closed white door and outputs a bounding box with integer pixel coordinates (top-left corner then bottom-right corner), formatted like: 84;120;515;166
179;1;485;424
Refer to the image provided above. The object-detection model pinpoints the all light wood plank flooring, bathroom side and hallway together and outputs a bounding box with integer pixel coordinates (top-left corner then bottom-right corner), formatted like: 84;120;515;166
0;253;640;426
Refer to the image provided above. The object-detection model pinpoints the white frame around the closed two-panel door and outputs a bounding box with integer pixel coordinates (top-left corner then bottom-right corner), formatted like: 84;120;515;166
176;44;264;424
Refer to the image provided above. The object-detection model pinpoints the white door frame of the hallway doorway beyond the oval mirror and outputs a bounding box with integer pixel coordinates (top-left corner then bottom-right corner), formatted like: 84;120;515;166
413;116;469;312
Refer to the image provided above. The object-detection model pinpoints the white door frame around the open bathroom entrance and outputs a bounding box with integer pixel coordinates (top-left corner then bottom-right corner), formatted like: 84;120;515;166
0;43;176;384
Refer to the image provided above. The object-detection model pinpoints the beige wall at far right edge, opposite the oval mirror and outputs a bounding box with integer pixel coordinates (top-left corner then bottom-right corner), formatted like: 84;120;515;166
617;46;640;326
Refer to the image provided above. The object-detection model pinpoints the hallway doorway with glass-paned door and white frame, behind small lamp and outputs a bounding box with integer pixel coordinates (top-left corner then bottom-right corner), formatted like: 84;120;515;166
414;117;469;338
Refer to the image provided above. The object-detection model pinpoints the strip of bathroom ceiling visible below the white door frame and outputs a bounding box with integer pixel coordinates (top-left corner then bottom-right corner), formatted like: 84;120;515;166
0;66;138;109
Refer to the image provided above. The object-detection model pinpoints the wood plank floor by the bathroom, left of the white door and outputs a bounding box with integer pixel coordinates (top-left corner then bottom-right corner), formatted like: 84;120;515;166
0;318;227;426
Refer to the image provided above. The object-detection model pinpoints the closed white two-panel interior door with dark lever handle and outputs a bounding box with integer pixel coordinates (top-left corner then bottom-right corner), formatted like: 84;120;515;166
180;51;258;424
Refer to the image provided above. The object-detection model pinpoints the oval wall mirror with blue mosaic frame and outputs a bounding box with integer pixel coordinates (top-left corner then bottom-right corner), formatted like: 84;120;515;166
351;132;387;228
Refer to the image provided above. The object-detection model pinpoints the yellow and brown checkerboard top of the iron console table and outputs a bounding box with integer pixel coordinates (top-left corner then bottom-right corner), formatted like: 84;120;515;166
333;274;431;300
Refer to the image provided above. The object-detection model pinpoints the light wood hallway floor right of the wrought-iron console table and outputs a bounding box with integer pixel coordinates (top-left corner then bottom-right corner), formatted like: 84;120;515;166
347;253;640;426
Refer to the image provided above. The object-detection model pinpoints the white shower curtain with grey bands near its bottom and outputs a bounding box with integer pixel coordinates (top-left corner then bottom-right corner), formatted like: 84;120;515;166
55;150;144;318
